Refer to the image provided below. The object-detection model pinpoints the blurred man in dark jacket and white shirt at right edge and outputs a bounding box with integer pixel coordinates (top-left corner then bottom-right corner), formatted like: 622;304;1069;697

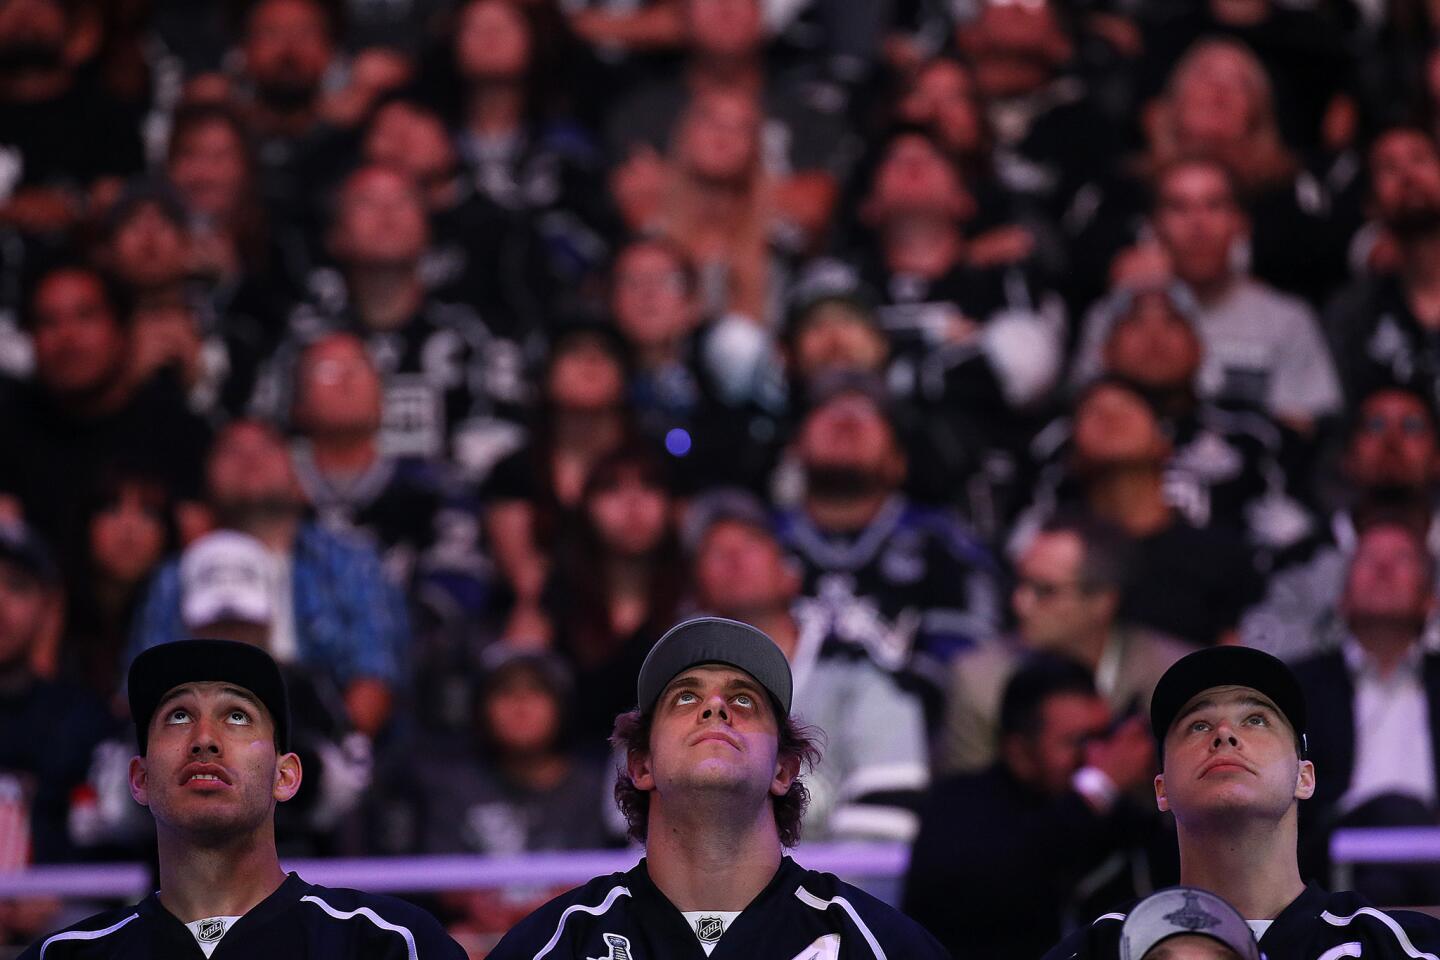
1295;521;1440;905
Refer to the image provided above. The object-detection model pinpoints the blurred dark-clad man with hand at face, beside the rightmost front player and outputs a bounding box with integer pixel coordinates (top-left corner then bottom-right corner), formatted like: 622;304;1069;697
901;653;1155;957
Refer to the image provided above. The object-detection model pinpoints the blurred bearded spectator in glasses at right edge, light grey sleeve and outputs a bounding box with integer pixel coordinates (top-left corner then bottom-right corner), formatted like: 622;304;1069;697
1240;386;1440;659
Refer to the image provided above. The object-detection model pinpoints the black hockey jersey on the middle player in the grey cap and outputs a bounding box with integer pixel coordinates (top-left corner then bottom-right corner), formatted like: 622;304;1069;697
490;856;949;960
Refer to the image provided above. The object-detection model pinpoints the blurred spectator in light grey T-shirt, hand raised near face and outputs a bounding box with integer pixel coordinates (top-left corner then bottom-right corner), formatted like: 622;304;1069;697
1073;158;1342;433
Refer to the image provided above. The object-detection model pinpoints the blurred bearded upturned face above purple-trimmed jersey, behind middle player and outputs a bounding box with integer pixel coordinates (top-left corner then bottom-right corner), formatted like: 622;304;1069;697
798;393;904;495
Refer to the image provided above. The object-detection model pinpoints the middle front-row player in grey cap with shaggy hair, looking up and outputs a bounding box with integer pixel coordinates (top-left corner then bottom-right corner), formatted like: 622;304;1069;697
490;617;949;960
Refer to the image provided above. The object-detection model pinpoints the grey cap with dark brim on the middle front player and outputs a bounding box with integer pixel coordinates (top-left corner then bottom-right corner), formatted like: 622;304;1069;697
635;616;793;717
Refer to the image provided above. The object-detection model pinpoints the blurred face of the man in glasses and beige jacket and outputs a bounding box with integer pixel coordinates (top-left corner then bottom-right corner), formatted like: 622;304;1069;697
1011;533;1120;653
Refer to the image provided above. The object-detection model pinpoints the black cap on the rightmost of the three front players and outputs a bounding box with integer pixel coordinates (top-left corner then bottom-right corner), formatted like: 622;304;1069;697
1151;646;1308;757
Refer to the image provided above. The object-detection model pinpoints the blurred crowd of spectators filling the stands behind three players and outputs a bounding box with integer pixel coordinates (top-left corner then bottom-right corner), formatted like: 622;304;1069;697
0;0;1440;959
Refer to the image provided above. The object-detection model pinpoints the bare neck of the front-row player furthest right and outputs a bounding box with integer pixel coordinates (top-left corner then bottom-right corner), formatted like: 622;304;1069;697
1179;806;1305;920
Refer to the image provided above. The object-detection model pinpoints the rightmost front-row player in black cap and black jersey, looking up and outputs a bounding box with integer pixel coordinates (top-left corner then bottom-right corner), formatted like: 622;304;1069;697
1045;646;1440;960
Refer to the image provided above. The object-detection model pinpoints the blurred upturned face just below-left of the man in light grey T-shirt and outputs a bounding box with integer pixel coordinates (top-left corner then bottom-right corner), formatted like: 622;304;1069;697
1104;291;1204;390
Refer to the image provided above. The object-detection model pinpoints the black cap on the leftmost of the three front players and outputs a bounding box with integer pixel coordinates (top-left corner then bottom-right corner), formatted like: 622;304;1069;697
128;640;289;756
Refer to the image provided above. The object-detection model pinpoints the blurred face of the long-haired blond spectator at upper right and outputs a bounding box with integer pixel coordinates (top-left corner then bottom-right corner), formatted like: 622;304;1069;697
1171;43;1266;154
